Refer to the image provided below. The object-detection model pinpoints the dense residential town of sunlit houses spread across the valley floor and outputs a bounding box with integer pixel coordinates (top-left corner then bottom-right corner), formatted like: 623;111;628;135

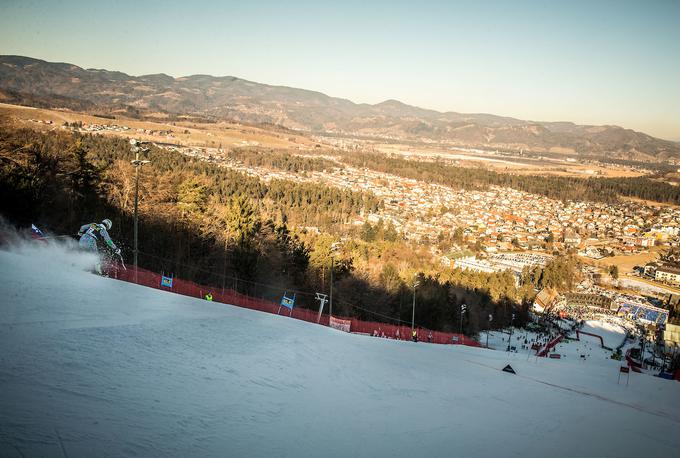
174;143;680;259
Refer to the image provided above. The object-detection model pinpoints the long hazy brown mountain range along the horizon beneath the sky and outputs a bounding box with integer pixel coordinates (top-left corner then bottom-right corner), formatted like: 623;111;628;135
0;56;680;161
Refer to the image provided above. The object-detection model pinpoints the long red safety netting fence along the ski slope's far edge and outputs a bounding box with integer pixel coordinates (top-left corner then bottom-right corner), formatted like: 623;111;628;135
108;266;481;347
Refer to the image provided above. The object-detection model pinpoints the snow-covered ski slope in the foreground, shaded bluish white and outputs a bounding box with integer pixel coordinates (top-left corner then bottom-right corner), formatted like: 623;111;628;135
0;242;680;457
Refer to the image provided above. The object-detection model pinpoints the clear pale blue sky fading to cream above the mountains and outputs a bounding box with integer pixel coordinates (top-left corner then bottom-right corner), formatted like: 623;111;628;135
0;0;680;140
